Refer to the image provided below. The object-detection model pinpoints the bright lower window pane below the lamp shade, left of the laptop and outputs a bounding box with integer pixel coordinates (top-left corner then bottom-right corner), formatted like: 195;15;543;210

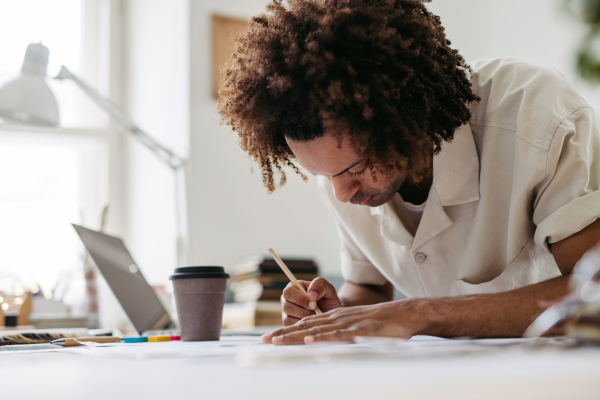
0;132;106;291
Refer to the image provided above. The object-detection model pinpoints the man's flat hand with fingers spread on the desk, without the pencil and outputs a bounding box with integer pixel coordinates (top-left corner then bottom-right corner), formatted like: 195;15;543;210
262;299;425;345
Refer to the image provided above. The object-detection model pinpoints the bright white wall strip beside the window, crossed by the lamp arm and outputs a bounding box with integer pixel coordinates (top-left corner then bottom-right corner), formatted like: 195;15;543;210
123;0;189;284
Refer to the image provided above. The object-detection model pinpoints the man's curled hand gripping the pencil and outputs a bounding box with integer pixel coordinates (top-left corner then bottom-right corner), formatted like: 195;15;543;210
281;278;342;326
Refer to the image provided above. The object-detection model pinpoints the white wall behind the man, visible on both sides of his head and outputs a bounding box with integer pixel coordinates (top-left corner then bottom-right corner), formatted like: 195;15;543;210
125;0;600;283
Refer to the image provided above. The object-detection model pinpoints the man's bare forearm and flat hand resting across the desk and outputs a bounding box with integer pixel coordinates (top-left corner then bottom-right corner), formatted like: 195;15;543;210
262;276;569;345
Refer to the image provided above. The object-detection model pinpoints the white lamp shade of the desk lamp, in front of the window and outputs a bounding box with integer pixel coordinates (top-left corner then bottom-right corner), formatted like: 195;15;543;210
0;43;59;126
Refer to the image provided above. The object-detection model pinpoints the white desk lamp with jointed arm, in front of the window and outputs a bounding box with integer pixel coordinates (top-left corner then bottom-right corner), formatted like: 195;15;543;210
0;43;188;266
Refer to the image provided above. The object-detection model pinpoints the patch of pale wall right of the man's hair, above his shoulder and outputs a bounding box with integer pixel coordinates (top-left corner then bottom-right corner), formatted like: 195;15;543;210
429;0;600;111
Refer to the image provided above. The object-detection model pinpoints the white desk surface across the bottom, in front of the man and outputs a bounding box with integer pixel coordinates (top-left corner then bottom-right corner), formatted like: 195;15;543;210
0;337;600;400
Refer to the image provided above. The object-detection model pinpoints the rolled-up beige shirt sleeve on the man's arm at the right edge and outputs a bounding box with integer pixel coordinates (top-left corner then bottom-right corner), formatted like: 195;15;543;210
533;107;600;247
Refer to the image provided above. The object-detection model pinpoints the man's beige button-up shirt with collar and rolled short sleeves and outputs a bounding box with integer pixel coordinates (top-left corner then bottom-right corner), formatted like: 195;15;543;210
319;58;600;297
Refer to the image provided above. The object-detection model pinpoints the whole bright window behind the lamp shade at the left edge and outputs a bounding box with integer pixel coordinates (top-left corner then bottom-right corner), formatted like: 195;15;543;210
0;0;108;304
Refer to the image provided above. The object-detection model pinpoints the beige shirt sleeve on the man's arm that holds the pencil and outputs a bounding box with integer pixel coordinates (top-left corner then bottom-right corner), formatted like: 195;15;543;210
318;177;388;285
